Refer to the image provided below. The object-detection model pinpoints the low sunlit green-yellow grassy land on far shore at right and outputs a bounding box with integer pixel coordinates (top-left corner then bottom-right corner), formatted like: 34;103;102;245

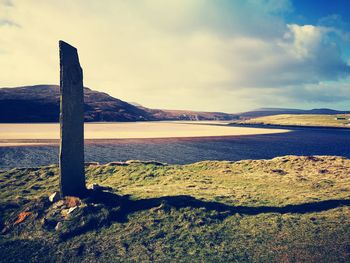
244;114;350;127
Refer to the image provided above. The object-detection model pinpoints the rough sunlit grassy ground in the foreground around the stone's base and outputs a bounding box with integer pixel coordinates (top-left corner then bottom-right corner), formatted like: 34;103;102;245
0;156;350;262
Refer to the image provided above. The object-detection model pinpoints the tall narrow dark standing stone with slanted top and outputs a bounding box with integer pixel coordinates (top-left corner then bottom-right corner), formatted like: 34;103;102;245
59;41;86;196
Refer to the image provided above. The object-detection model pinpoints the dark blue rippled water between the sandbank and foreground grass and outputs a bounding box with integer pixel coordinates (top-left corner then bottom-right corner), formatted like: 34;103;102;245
0;125;350;169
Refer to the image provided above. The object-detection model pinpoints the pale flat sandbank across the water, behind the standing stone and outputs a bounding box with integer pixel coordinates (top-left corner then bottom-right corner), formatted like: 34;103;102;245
0;122;289;147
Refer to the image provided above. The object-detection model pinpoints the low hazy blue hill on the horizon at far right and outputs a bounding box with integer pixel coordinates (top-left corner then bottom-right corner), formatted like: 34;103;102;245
238;108;350;119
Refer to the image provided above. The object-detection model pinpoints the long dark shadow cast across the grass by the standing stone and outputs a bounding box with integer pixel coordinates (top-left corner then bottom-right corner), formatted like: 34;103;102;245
56;190;350;240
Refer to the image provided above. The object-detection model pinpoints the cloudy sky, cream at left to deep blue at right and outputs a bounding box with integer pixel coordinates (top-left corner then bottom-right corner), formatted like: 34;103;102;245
0;0;350;113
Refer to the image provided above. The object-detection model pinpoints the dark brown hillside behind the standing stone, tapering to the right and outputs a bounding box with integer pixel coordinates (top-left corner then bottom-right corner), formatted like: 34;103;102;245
0;85;237;123
